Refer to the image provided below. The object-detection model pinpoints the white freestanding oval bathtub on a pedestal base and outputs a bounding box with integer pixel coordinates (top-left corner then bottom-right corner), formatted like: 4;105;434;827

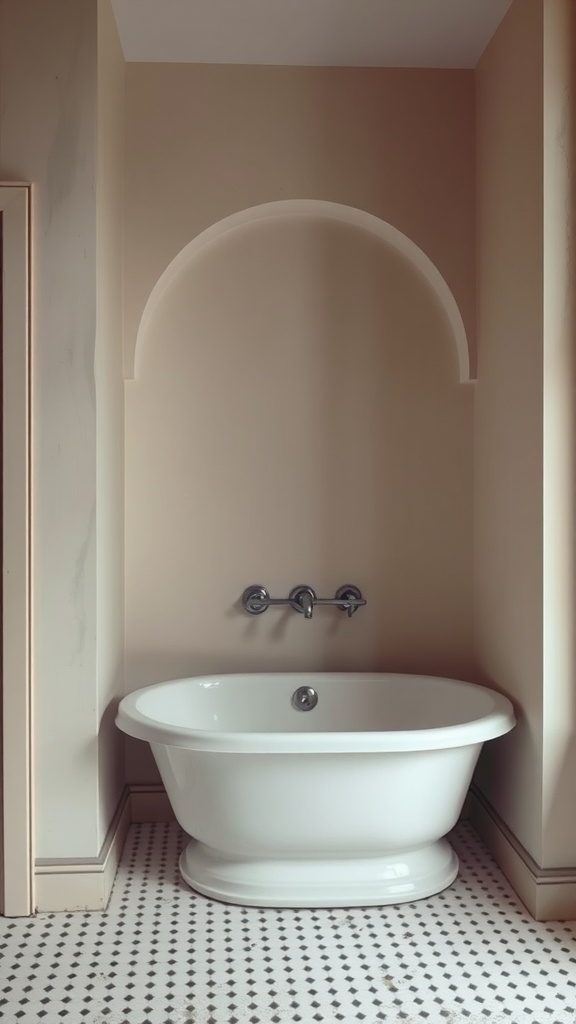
117;673;515;907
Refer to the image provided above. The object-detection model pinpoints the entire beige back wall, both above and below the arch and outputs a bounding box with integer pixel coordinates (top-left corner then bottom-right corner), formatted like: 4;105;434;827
125;66;474;781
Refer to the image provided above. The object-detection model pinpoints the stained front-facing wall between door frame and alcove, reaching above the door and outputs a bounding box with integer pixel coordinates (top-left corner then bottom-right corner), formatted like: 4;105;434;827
0;0;98;857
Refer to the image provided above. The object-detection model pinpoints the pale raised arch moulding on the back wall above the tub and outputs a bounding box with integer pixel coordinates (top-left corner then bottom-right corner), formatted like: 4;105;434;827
126;200;474;383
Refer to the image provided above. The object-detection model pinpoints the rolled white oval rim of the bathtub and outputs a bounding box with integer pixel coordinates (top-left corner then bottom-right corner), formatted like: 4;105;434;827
116;672;516;754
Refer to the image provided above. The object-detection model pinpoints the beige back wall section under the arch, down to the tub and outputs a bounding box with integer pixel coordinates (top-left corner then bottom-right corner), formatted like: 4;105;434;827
126;207;472;704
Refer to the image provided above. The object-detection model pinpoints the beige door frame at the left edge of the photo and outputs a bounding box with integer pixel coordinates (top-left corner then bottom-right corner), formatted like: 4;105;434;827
0;182;34;916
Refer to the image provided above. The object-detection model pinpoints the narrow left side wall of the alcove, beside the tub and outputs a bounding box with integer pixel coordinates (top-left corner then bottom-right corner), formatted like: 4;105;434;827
94;0;124;845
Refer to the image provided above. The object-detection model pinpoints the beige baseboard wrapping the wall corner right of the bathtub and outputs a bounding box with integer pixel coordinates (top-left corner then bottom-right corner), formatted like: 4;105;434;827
468;786;576;921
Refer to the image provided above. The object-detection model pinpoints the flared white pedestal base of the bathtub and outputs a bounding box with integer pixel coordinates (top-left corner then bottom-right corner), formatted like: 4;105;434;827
180;839;458;907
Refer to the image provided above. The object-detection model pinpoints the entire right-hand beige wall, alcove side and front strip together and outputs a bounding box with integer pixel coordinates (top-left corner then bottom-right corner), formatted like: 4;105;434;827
475;0;576;867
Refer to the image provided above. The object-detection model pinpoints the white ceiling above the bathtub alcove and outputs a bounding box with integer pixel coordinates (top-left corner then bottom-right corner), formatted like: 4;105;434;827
112;0;511;68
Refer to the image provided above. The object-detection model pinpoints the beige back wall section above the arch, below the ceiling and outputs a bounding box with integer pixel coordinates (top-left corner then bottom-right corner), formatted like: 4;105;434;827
125;63;476;377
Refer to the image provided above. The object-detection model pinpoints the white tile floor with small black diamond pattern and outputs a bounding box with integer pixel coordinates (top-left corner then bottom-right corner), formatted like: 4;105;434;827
0;824;576;1024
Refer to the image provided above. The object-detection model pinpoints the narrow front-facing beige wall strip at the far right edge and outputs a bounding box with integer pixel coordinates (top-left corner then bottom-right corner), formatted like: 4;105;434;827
542;0;576;866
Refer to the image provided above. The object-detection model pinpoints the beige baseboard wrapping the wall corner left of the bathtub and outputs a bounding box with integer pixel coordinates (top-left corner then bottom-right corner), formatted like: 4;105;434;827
34;787;131;911
